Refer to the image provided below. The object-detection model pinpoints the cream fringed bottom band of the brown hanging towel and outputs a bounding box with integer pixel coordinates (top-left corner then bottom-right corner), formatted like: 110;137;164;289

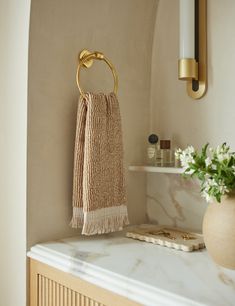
70;205;129;235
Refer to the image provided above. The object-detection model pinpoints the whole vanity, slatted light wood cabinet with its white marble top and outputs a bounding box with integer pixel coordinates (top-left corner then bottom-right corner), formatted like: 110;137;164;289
27;231;235;306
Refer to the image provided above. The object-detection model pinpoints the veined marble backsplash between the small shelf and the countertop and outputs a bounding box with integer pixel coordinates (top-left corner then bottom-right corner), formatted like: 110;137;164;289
147;173;207;231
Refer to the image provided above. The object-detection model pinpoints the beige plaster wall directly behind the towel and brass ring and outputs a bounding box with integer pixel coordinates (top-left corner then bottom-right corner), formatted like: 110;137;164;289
28;0;158;246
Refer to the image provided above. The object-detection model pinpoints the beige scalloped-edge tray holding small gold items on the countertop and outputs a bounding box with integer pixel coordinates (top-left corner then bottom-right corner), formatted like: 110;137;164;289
126;225;205;252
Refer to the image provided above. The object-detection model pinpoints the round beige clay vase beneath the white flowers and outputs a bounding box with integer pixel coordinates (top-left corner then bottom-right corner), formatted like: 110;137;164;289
203;193;235;269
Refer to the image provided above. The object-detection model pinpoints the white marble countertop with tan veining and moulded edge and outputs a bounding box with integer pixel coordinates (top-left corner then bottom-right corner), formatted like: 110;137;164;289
28;226;235;306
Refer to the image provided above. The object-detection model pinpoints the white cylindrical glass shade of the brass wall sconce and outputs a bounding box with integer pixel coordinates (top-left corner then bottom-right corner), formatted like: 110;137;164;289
179;0;195;59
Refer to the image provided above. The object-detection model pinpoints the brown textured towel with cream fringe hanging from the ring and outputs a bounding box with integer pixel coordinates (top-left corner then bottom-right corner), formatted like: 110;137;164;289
71;93;129;235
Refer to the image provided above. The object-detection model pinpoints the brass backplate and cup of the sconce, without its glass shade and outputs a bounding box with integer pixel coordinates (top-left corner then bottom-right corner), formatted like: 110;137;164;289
179;0;207;99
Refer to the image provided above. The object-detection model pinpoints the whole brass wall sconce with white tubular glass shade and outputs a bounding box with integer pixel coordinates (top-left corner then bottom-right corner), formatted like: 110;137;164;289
178;0;207;99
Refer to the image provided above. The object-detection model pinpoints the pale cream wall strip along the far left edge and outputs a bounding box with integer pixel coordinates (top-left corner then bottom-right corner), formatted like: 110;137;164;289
0;0;30;306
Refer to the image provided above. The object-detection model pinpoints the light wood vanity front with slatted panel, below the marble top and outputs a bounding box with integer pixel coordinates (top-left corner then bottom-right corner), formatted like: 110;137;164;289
30;259;141;306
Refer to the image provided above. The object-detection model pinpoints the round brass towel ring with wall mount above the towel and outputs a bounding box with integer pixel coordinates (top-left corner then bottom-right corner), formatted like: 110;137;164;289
76;49;118;96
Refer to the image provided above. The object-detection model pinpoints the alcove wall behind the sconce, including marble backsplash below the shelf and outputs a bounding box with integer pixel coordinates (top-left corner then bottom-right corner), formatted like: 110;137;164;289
147;0;235;230
